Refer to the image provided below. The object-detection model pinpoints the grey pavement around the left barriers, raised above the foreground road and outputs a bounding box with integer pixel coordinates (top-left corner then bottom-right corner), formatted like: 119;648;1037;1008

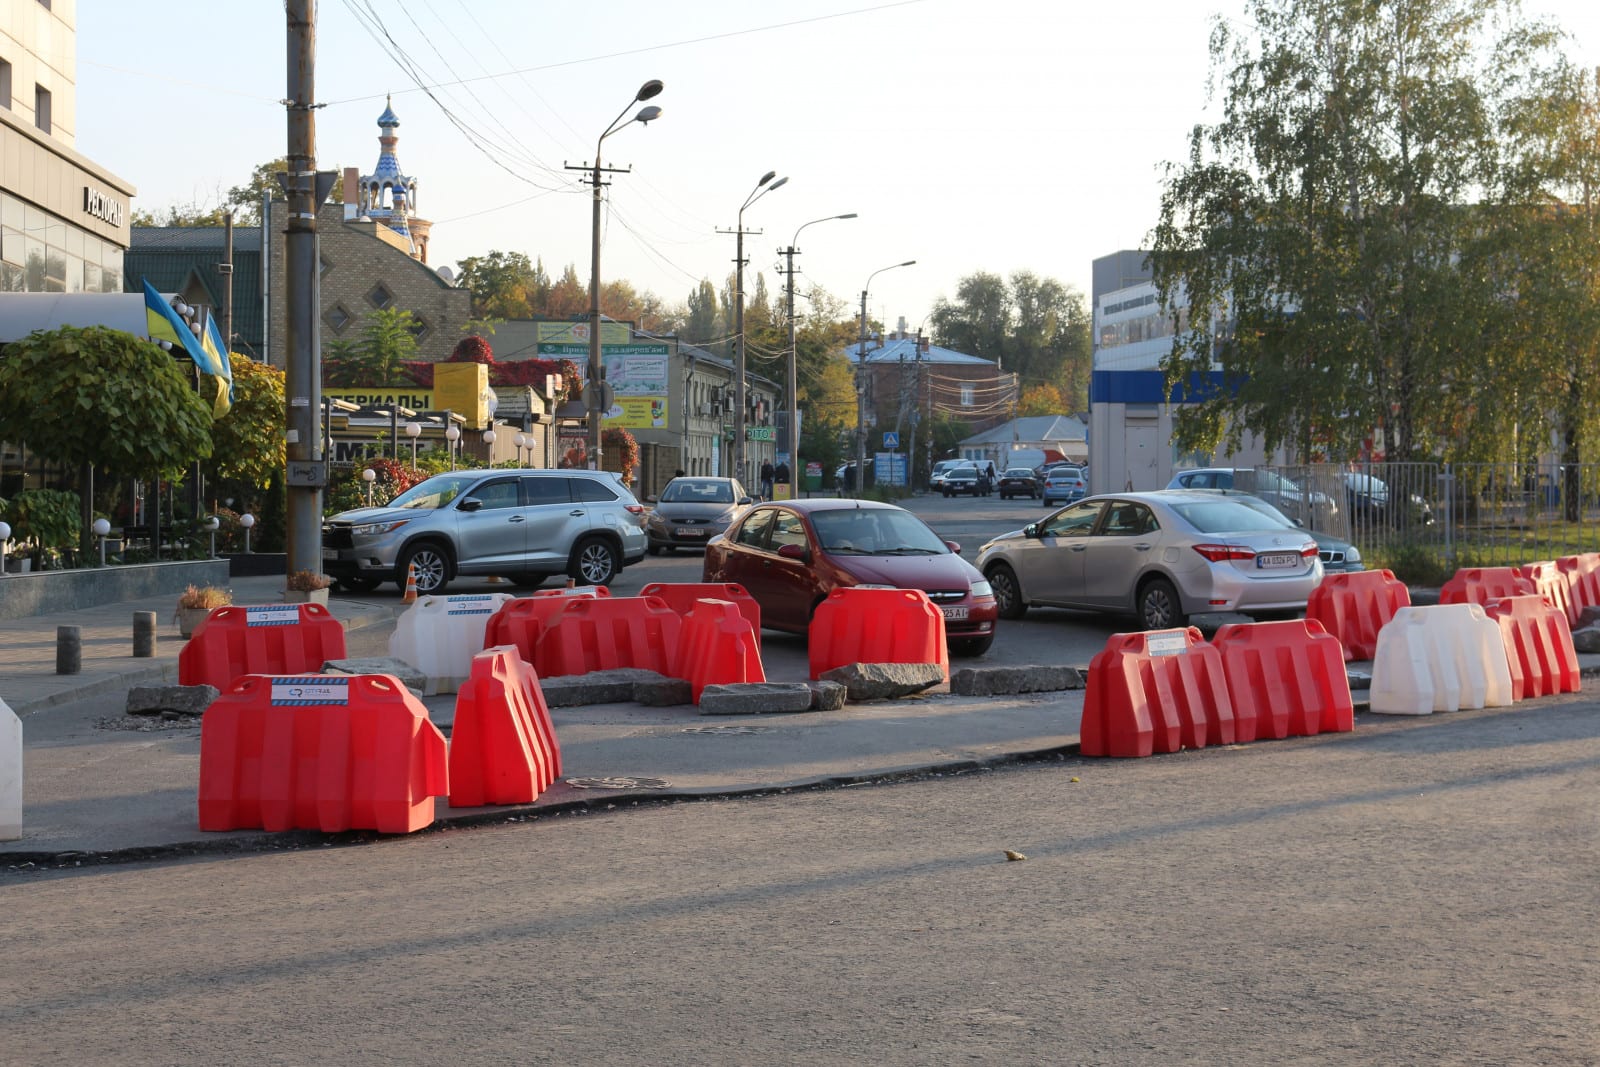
0;576;1600;870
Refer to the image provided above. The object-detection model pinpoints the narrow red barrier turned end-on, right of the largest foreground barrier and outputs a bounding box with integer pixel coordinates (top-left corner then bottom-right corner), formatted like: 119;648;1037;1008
450;645;562;808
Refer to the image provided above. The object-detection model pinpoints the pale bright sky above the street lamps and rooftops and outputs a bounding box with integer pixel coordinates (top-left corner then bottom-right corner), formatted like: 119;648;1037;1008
77;0;1600;330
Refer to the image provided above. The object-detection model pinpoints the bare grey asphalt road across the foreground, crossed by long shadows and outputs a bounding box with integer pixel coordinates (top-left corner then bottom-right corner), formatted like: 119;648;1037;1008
0;699;1600;1065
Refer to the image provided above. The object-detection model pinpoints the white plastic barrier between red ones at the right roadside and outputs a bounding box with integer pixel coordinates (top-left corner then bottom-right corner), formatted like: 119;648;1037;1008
1370;605;1512;715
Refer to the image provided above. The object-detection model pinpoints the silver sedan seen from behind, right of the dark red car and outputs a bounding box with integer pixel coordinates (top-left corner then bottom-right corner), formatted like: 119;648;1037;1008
978;493;1323;630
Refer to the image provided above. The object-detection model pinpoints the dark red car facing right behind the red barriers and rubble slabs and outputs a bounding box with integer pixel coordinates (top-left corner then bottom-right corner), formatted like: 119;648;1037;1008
704;498;1000;656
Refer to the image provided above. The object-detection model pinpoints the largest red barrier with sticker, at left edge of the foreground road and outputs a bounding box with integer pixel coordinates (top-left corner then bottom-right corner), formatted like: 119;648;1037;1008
200;675;450;833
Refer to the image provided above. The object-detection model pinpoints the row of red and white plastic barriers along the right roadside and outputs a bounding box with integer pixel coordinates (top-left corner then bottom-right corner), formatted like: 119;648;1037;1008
1080;553;1600;757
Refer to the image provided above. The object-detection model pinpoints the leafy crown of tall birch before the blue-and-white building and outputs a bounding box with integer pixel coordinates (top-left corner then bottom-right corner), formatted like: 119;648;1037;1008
1150;0;1554;461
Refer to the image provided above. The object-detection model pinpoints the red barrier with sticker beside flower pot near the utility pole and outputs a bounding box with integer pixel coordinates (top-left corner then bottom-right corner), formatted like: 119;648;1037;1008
178;603;346;691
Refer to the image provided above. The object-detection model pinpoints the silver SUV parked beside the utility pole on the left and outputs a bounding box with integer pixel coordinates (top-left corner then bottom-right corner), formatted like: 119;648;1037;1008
322;470;646;593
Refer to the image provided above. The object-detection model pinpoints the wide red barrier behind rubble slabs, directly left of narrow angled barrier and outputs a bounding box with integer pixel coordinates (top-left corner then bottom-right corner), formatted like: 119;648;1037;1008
533;597;683;678
